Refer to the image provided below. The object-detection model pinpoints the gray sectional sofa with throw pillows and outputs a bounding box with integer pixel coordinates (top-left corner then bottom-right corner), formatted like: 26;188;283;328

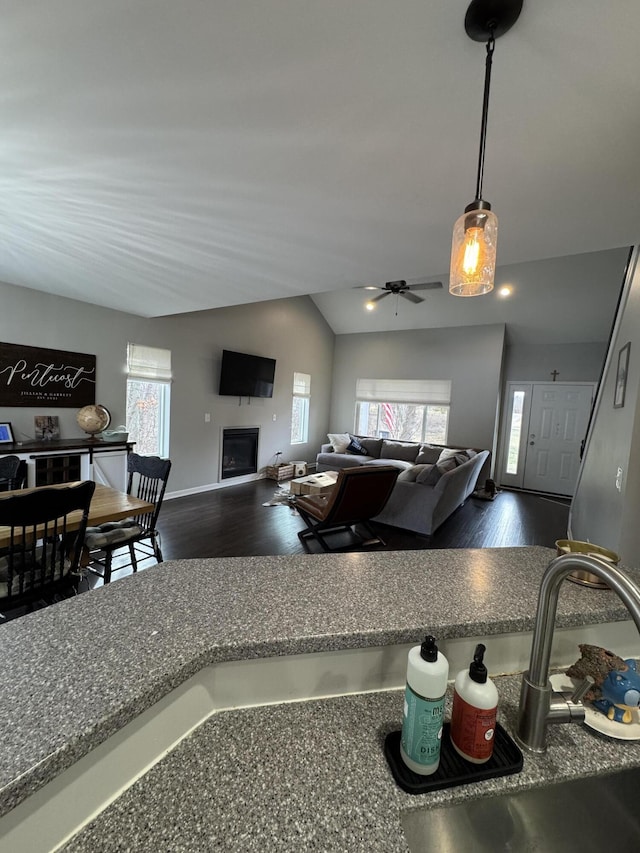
316;433;490;536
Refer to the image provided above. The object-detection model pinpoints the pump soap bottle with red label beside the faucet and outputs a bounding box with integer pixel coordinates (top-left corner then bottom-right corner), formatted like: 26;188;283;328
451;643;498;764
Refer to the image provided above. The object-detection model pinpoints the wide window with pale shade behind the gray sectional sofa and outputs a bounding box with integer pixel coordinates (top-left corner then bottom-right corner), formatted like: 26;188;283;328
354;379;451;444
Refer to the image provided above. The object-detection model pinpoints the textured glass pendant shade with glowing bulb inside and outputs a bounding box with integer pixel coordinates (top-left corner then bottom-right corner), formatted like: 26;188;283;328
449;202;498;296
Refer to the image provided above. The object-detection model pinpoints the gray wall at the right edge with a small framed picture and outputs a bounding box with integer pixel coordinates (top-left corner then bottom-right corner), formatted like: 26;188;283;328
570;247;640;566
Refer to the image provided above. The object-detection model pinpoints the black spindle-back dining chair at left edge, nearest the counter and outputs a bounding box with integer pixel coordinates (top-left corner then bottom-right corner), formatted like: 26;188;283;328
0;480;96;613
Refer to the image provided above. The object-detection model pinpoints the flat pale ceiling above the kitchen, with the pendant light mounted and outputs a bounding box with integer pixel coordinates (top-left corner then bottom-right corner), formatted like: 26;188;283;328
0;0;640;328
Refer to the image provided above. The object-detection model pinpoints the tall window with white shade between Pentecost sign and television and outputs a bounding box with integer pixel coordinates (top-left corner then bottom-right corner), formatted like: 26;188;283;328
127;343;171;457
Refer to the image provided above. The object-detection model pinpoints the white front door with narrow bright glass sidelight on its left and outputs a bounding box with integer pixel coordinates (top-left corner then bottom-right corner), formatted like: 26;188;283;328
500;382;594;496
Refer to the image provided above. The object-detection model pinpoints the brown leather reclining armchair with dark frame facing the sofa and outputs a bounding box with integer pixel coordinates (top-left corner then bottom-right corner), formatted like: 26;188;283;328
293;465;400;551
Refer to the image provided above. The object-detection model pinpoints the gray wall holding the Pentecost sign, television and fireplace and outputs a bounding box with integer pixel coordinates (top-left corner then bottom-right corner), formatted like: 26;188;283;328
0;284;335;493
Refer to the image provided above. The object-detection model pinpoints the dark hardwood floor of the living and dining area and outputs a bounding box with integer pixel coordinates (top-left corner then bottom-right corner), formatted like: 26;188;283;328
0;480;569;621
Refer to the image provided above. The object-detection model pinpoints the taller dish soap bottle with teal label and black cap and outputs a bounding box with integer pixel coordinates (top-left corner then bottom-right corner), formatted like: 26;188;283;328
400;635;449;776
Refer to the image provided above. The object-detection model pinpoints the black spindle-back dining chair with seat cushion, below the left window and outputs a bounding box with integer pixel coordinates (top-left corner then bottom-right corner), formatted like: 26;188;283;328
84;453;171;584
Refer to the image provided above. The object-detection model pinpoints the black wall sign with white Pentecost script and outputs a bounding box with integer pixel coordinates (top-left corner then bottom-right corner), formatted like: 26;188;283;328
0;343;96;409
